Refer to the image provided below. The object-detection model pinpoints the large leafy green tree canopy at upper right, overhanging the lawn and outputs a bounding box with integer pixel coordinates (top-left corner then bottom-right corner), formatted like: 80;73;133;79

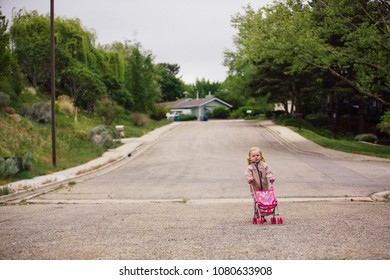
226;0;390;133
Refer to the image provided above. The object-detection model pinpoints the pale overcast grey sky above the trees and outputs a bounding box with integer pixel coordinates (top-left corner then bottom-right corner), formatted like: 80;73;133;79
0;0;273;84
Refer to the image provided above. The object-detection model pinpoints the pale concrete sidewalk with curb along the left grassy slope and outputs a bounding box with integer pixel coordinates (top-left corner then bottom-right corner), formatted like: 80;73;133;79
0;122;180;204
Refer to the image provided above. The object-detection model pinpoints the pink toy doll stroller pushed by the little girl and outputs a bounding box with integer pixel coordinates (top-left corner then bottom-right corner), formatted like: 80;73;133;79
250;185;283;224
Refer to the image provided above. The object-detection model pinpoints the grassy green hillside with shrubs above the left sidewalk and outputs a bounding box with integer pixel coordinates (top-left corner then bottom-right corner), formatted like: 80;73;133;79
0;91;167;185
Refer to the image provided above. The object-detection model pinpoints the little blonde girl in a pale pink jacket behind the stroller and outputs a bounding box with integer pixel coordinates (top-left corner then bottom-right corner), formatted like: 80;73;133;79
245;147;275;190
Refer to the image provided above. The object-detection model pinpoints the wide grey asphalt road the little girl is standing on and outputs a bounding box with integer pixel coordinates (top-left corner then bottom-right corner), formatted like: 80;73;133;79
0;121;390;260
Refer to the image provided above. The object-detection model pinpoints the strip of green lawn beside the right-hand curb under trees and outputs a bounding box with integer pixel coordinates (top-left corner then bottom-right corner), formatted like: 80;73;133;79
290;127;390;159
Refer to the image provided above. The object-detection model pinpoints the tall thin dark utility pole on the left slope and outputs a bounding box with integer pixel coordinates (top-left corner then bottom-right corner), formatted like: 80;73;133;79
50;0;57;167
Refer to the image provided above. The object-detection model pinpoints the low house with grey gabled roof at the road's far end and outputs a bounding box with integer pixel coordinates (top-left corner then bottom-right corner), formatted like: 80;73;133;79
164;94;233;120
